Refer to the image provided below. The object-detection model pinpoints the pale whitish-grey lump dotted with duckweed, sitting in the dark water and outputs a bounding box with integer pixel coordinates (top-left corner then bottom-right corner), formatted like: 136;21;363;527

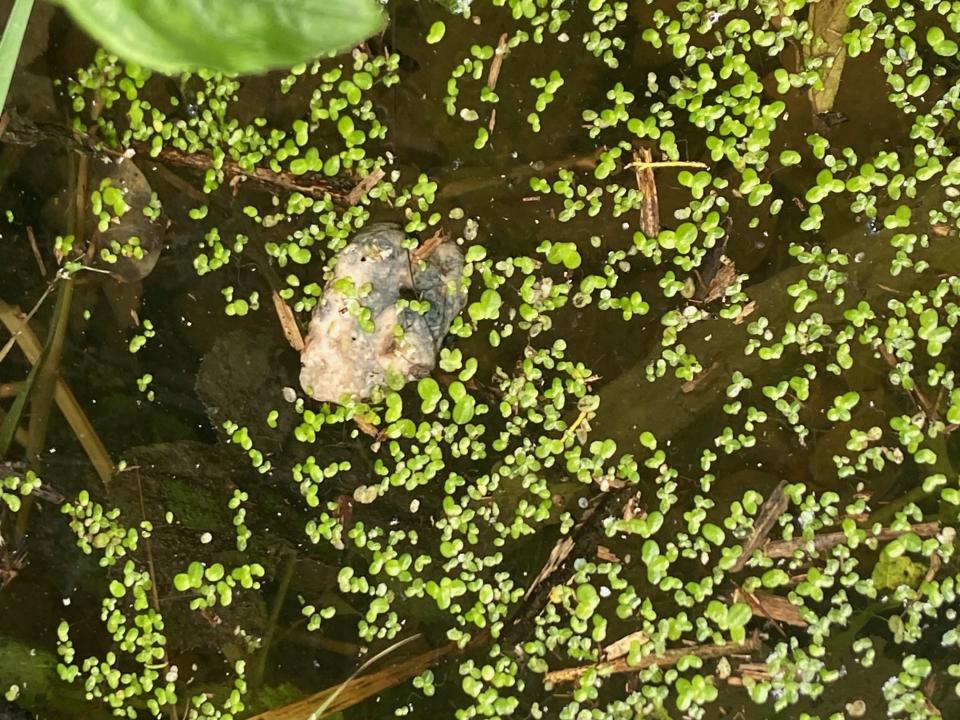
300;223;466;402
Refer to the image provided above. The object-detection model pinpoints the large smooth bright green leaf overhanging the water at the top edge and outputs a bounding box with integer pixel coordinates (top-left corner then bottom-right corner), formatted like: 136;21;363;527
59;0;384;74
